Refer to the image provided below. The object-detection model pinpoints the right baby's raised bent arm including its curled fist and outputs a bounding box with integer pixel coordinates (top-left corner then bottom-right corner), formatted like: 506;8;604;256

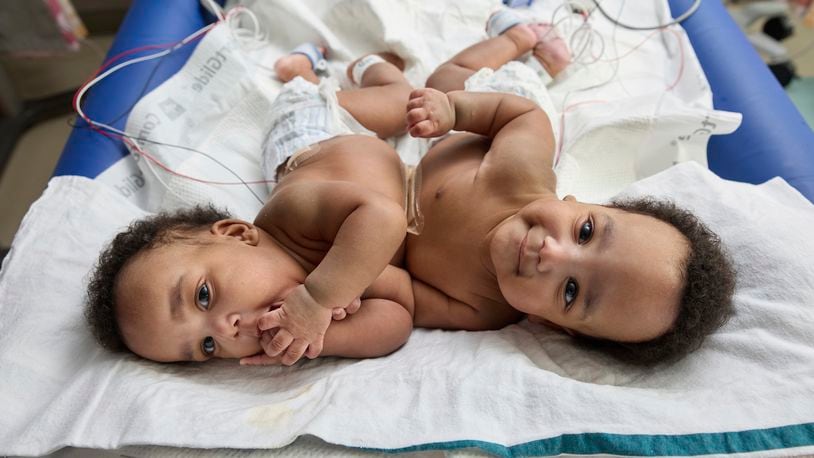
407;88;555;188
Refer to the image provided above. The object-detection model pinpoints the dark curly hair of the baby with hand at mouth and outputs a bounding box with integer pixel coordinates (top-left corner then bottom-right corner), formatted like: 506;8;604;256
85;205;230;351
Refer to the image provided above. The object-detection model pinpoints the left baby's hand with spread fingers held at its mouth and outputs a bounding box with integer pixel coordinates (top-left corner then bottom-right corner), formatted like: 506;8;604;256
257;285;333;366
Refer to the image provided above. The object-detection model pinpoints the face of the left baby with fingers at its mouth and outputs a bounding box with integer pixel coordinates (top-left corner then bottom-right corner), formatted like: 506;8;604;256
115;223;305;362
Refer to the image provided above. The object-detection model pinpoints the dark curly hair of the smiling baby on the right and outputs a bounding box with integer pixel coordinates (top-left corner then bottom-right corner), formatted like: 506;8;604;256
576;198;736;366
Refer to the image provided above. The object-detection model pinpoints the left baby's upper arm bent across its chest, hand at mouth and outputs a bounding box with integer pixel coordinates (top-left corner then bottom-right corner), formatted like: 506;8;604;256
259;181;406;365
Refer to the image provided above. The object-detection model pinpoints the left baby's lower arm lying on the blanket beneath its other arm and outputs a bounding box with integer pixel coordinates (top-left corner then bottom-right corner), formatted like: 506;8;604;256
240;265;414;365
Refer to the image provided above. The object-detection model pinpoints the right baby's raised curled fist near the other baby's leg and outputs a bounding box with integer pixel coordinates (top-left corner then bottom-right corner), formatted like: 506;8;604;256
407;88;455;138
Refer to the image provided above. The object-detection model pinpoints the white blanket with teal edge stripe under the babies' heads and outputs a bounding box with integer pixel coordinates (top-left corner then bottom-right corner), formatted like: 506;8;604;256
0;163;814;456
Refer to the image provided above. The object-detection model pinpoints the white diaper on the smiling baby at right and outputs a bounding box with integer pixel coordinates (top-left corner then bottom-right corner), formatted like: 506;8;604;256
464;61;560;158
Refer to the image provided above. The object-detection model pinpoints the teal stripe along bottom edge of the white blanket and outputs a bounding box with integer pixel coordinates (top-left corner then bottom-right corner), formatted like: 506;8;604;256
363;423;814;457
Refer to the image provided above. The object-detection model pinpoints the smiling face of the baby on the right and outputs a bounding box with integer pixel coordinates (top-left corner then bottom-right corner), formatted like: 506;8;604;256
490;197;688;342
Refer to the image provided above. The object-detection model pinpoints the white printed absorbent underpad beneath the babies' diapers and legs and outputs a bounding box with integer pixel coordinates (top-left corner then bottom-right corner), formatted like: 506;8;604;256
111;0;741;219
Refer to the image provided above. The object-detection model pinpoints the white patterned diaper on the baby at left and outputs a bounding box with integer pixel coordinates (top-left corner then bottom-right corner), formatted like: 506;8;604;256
263;76;376;180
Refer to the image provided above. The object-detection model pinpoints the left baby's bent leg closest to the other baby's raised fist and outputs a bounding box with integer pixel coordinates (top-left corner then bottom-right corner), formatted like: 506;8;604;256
337;53;413;138
